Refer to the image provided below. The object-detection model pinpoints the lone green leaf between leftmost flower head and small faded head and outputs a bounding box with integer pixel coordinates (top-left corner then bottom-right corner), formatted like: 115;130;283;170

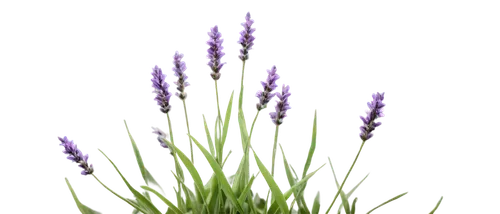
121;118;165;194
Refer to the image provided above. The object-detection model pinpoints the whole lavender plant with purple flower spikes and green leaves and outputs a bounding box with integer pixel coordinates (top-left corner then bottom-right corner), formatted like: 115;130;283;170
57;8;444;214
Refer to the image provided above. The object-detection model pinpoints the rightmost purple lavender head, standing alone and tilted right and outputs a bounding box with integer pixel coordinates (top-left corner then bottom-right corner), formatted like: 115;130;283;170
358;90;387;142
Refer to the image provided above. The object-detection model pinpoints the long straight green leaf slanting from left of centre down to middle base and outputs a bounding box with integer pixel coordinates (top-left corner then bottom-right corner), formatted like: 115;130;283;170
193;135;243;213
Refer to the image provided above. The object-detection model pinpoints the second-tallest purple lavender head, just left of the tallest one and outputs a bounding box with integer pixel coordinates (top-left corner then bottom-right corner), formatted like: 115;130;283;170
205;24;226;80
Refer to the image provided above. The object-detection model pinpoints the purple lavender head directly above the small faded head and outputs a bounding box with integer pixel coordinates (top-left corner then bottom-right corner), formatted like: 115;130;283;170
149;65;174;114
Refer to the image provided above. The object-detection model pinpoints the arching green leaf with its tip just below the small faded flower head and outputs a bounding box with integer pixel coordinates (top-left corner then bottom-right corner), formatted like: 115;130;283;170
154;135;206;200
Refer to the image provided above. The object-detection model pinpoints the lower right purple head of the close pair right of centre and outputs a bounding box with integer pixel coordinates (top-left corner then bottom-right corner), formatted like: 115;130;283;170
267;82;293;126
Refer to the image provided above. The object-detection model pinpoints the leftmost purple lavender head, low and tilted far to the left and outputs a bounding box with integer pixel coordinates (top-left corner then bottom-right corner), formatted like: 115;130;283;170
56;135;96;177
